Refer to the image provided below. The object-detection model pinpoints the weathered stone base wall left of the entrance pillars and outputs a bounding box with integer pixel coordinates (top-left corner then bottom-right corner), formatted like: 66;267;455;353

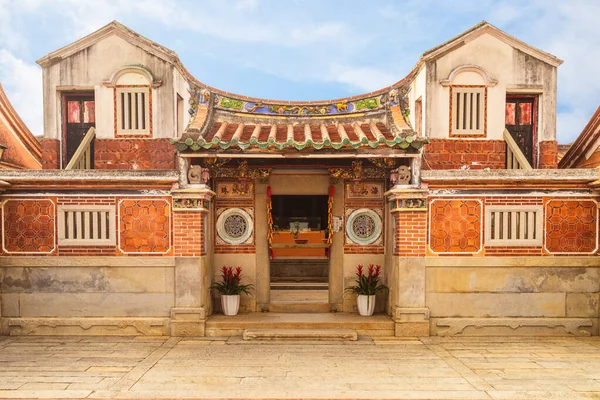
0;257;175;335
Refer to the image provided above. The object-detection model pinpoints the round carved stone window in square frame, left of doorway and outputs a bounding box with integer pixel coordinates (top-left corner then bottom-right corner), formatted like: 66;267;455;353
216;207;254;245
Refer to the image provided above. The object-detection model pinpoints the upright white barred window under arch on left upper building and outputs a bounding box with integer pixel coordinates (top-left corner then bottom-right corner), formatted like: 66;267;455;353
115;86;152;135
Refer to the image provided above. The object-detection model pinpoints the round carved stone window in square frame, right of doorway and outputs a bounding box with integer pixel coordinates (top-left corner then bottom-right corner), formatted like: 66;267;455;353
346;208;383;246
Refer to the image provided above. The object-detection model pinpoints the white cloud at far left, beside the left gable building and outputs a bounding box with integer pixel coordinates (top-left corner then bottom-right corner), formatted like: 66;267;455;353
0;49;44;135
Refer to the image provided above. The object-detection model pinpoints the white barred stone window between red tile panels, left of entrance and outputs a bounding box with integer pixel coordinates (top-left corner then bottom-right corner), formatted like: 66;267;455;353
58;205;116;246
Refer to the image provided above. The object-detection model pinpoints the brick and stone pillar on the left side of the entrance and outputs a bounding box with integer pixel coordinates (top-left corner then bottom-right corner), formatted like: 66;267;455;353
171;185;215;336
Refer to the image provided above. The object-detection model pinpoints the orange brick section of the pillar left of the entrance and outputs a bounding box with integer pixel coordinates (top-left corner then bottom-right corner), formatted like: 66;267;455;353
173;211;206;257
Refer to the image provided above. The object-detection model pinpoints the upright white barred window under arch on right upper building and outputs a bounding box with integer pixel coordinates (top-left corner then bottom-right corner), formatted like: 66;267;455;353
450;86;487;136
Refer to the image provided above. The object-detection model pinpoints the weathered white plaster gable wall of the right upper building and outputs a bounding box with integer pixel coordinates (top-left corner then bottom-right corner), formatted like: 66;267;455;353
424;34;556;141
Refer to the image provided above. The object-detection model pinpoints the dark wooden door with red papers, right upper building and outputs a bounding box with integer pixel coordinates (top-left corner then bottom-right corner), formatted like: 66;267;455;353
505;97;536;166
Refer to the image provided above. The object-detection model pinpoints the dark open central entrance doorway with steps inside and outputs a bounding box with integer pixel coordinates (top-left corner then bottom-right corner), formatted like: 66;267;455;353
269;195;330;312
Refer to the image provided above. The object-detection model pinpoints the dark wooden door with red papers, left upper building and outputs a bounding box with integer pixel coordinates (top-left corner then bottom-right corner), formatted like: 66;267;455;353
63;93;96;167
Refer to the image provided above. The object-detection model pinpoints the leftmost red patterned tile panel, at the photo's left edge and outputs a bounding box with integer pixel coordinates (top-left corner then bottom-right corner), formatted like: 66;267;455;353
2;199;56;254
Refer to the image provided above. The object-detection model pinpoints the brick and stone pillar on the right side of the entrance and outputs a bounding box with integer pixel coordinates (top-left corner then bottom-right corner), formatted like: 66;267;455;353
386;185;429;336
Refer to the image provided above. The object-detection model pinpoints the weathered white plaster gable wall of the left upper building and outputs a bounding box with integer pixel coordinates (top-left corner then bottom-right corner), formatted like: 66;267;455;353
43;35;179;139
